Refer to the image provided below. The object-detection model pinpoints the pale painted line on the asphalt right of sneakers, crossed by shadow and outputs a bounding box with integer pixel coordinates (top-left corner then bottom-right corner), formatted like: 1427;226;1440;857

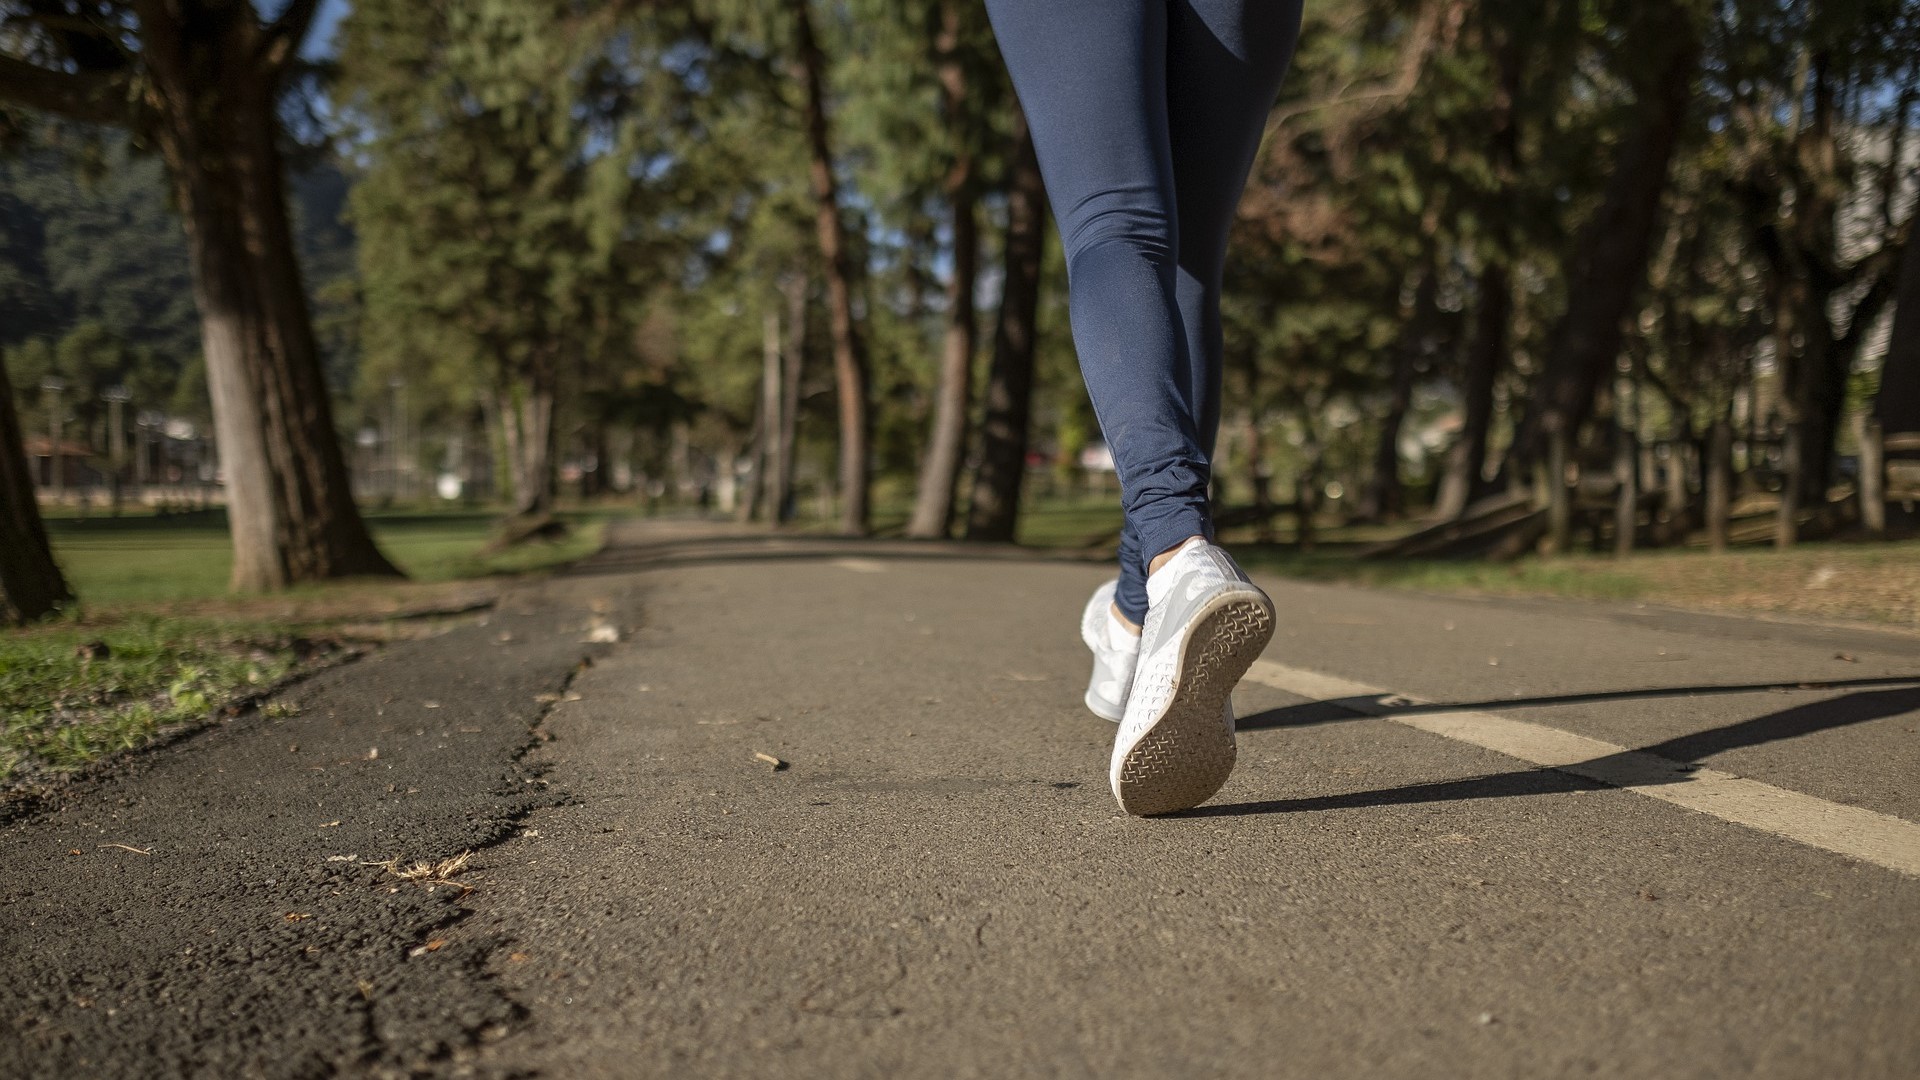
1246;659;1920;878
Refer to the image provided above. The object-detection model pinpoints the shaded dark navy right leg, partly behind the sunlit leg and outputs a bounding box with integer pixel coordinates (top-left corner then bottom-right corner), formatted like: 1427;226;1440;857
1167;0;1300;463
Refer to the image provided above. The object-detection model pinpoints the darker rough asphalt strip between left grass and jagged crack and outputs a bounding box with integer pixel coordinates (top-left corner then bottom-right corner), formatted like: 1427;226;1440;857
0;586;629;1078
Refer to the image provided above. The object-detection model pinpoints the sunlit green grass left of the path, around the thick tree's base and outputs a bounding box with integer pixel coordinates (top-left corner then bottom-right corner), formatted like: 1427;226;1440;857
0;499;616;788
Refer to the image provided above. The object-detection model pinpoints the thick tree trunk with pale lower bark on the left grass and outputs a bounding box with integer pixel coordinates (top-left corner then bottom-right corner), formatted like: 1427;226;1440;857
140;4;399;590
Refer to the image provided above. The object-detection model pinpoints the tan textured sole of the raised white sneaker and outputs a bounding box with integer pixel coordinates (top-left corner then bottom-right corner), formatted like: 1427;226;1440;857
1112;590;1273;817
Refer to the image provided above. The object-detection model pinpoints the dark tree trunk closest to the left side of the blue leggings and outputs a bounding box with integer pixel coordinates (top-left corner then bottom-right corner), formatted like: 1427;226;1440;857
966;106;1046;542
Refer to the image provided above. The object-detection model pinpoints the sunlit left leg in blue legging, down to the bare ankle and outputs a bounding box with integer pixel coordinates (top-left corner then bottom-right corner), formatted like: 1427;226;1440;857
987;0;1212;623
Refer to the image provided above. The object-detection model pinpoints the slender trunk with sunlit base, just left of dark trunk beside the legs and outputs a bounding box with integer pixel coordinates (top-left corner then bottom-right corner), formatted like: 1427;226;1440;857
906;0;979;540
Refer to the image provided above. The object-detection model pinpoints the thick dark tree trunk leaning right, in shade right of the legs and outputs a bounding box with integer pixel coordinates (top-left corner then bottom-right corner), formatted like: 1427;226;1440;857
1513;14;1699;475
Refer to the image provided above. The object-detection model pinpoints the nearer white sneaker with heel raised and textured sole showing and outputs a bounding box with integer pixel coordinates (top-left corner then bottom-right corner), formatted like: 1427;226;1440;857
1108;536;1273;817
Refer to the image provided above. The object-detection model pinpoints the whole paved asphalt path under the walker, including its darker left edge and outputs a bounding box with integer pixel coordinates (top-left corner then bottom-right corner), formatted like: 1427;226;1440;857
0;525;1920;1078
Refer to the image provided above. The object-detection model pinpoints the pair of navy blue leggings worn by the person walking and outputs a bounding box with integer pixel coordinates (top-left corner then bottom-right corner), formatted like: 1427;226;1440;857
987;0;1300;623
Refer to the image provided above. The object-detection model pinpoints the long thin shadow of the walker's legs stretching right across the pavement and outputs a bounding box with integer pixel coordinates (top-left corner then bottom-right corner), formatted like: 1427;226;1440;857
1198;678;1920;817
